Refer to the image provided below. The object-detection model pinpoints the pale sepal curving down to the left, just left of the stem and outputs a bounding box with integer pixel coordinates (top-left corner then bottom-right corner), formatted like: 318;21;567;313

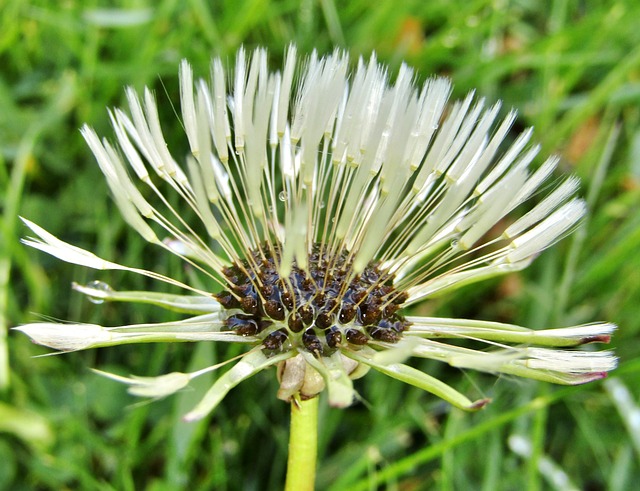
183;349;294;421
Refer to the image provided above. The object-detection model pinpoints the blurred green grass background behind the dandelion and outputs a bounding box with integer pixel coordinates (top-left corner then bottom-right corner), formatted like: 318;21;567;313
0;0;640;490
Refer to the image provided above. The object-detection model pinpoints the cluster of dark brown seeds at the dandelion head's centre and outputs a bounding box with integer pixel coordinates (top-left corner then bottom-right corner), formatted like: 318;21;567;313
216;245;409;356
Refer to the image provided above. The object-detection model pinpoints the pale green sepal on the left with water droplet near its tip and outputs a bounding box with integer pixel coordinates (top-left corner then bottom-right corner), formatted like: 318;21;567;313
71;282;221;314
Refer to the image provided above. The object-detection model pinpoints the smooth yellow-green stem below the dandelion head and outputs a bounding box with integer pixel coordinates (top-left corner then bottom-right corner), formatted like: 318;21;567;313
285;397;319;491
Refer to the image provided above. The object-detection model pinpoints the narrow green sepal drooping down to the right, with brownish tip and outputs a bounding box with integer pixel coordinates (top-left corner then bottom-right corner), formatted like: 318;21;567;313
344;351;489;411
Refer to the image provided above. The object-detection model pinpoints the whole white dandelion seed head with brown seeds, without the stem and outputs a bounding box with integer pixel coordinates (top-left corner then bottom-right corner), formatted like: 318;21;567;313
17;47;616;420
